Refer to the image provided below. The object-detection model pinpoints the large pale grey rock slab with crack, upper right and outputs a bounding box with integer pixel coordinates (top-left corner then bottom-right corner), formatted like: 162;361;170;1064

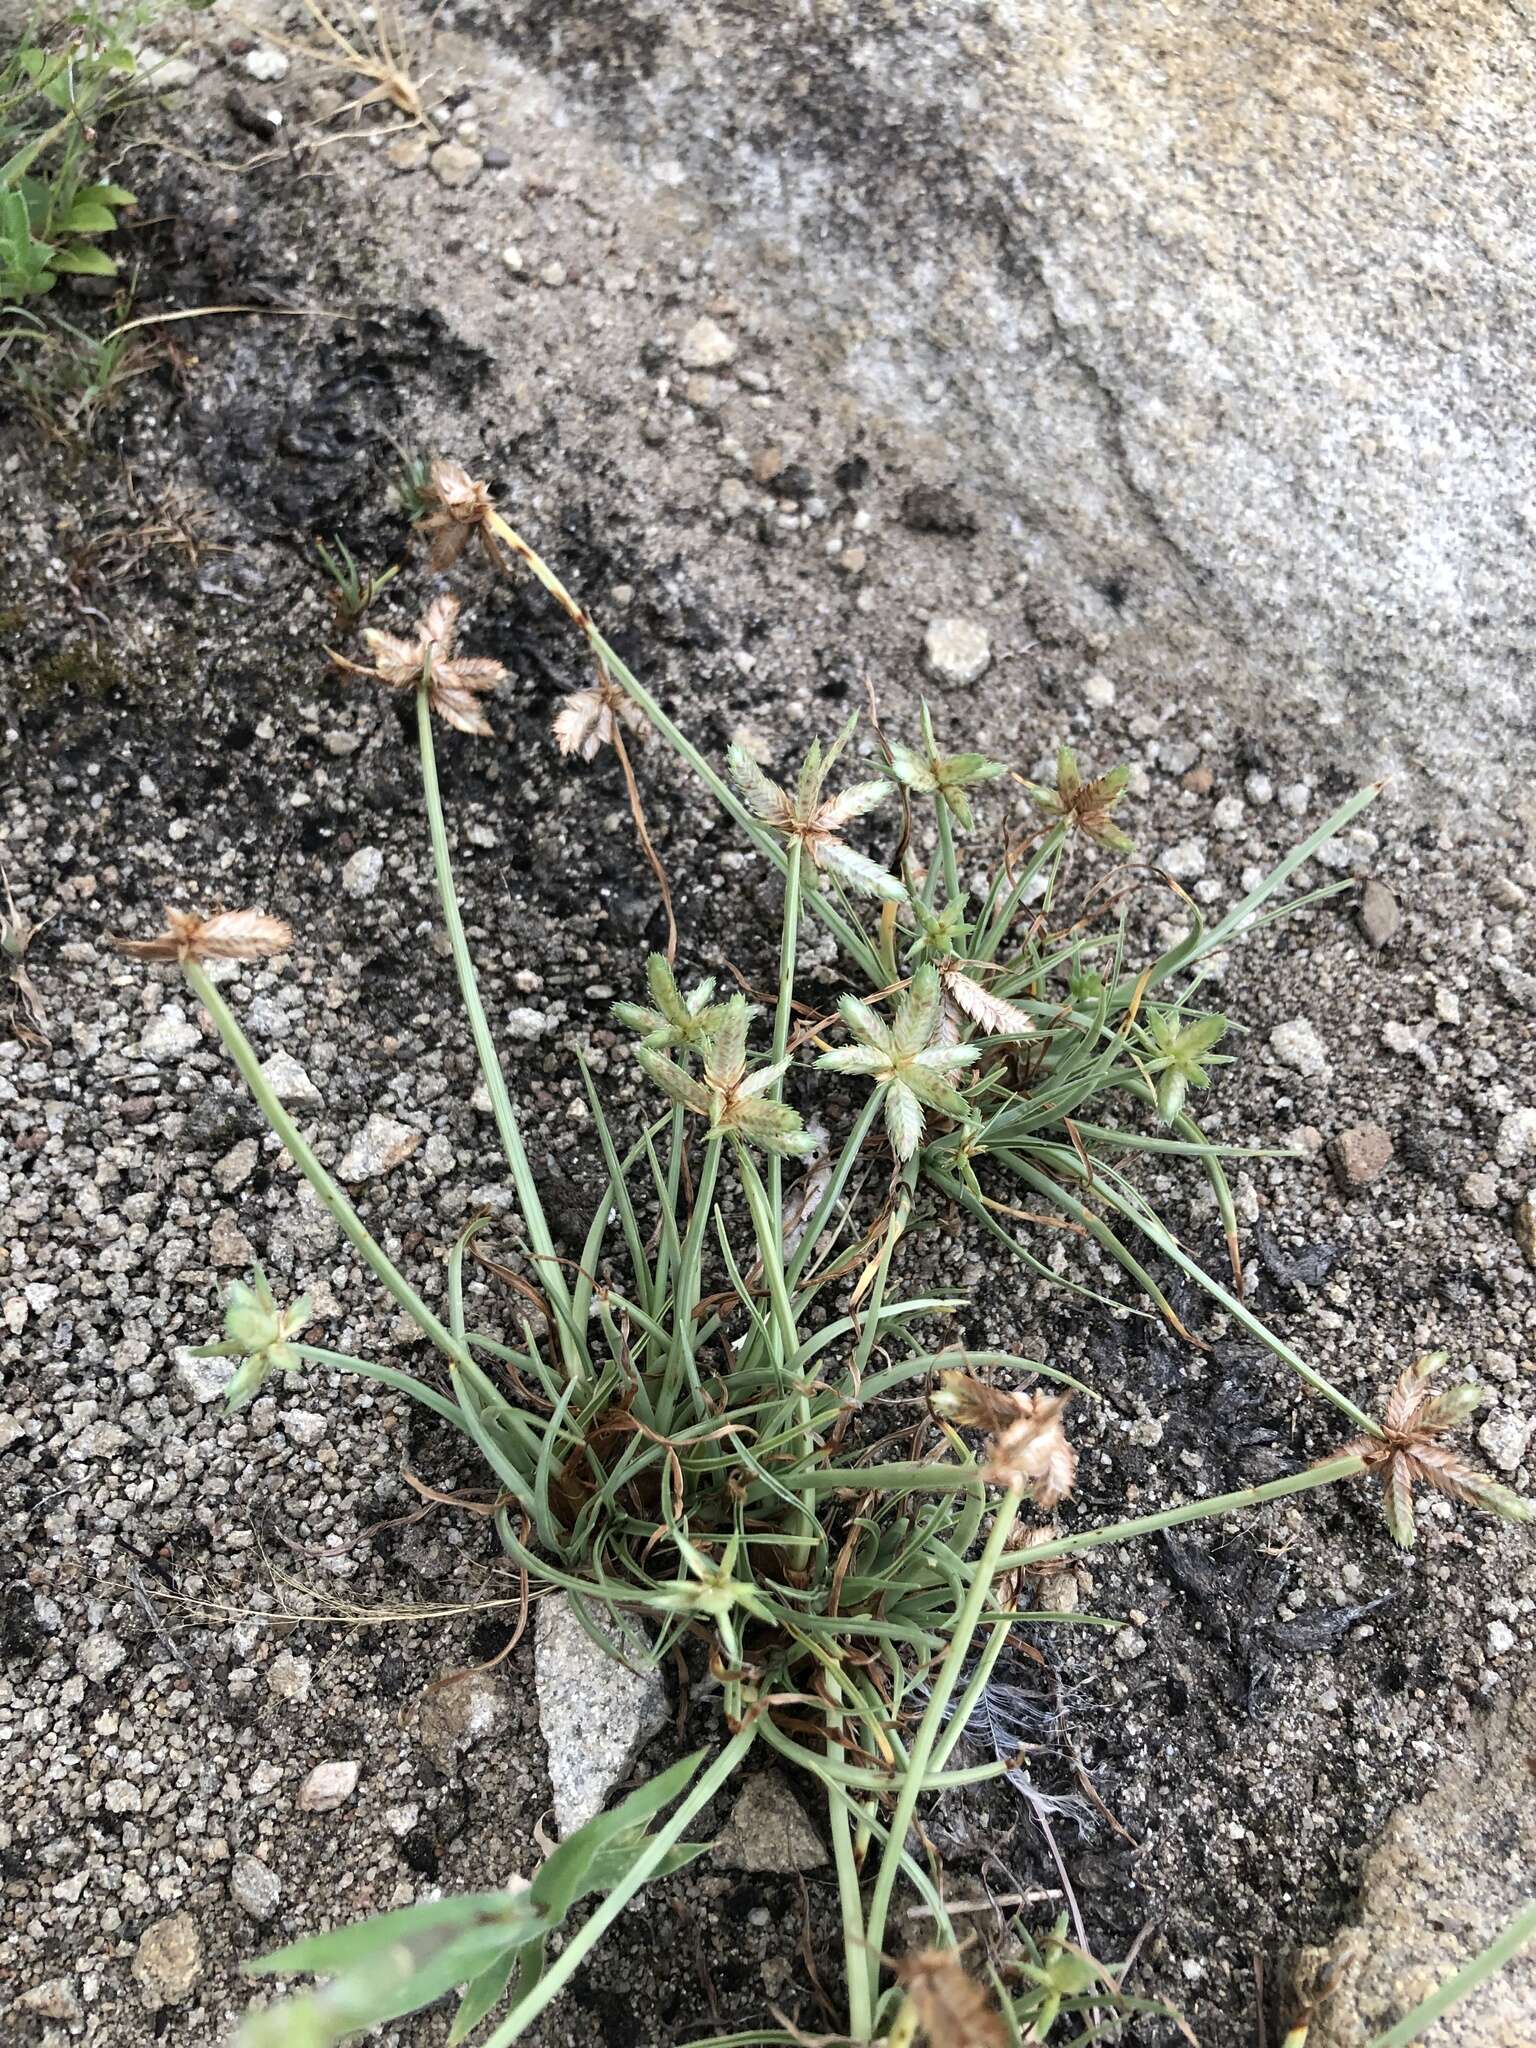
536;0;1536;791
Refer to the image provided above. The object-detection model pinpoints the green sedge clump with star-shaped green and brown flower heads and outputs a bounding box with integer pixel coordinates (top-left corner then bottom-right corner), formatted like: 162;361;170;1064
108;548;1526;2048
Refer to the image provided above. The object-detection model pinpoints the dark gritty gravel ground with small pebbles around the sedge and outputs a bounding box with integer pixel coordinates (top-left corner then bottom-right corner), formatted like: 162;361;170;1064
0;8;1536;2048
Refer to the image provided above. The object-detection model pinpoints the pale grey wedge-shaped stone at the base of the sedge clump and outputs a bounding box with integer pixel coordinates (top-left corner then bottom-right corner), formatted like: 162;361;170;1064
532;1593;668;1835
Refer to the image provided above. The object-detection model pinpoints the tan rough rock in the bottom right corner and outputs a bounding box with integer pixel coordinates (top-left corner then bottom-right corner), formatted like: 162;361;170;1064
1296;1688;1536;2048
